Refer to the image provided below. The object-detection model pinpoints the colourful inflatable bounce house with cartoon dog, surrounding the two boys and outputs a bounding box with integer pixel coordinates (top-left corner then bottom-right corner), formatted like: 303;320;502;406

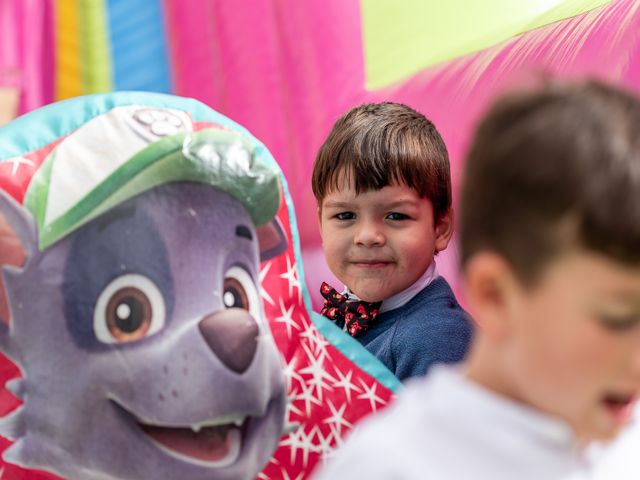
0;0;640;480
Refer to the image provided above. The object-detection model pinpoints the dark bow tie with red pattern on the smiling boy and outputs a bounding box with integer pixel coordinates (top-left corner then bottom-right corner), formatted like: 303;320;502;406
320;282;382;337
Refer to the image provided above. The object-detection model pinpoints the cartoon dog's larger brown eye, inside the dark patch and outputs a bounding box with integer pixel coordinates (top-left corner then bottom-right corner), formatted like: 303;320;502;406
93;274;165;343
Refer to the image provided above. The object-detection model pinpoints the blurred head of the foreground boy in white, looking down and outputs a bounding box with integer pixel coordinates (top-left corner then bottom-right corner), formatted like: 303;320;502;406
460;82;640;438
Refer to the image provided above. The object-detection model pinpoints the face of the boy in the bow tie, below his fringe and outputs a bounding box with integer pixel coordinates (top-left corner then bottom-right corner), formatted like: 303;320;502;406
318;178;452;302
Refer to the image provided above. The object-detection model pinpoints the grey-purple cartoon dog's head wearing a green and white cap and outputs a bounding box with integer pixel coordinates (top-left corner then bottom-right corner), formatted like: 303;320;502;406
0;94;286;480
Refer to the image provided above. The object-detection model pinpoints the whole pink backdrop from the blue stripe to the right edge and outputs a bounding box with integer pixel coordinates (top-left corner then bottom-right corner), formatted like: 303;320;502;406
158;0;640;305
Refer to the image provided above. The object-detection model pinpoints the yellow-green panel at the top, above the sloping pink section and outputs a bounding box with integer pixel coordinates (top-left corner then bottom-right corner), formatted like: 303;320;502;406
361;0;610;89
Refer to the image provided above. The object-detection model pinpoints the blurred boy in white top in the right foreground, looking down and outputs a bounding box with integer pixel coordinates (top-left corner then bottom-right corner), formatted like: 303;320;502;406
320;82;640;480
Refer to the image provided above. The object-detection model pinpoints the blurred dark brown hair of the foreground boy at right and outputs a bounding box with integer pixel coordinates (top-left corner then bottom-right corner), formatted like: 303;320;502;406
460;81;640;283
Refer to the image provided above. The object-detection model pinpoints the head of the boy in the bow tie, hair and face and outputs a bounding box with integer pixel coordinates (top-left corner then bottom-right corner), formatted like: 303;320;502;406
312;102;453;302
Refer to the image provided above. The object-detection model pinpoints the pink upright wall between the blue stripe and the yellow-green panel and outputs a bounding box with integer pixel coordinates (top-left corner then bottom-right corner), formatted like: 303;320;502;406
166;0;364;236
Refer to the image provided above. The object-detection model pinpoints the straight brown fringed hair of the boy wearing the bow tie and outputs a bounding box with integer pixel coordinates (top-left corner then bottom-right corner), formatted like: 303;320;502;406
311;102;451;221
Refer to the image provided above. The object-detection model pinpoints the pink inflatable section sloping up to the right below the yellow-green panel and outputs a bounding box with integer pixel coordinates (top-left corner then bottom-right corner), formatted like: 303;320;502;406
364;0;640;303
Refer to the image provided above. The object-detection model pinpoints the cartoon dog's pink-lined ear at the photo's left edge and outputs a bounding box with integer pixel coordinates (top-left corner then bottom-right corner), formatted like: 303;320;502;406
0;190;37;325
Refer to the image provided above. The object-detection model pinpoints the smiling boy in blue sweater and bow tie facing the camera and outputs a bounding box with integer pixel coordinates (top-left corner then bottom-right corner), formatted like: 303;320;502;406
312;103;472;380
